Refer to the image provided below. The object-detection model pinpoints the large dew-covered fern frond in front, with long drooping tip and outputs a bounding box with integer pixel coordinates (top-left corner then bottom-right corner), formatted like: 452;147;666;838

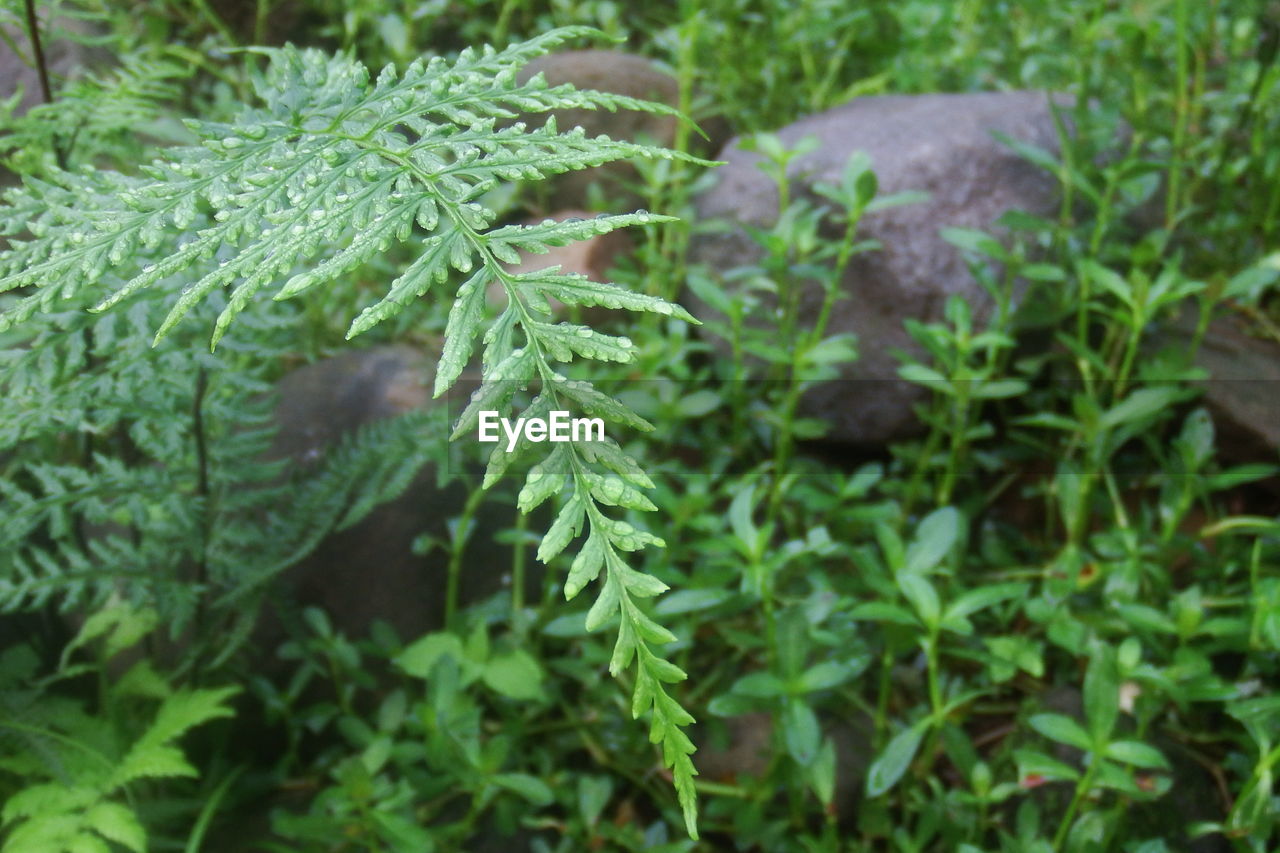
0;27;705;836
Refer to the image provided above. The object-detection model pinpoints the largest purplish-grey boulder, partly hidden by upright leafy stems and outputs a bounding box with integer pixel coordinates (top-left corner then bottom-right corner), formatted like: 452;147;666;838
686;92;1059;446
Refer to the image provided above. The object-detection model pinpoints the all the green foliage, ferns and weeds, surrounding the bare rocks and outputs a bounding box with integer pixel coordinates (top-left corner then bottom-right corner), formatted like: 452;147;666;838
0;0;1280;853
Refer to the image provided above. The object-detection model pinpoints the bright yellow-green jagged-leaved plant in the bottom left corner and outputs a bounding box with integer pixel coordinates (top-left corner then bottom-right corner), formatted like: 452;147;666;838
0;601;239;853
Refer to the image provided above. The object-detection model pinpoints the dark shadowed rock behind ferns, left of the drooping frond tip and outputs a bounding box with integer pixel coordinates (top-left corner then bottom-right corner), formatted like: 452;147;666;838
260;346;515;643
